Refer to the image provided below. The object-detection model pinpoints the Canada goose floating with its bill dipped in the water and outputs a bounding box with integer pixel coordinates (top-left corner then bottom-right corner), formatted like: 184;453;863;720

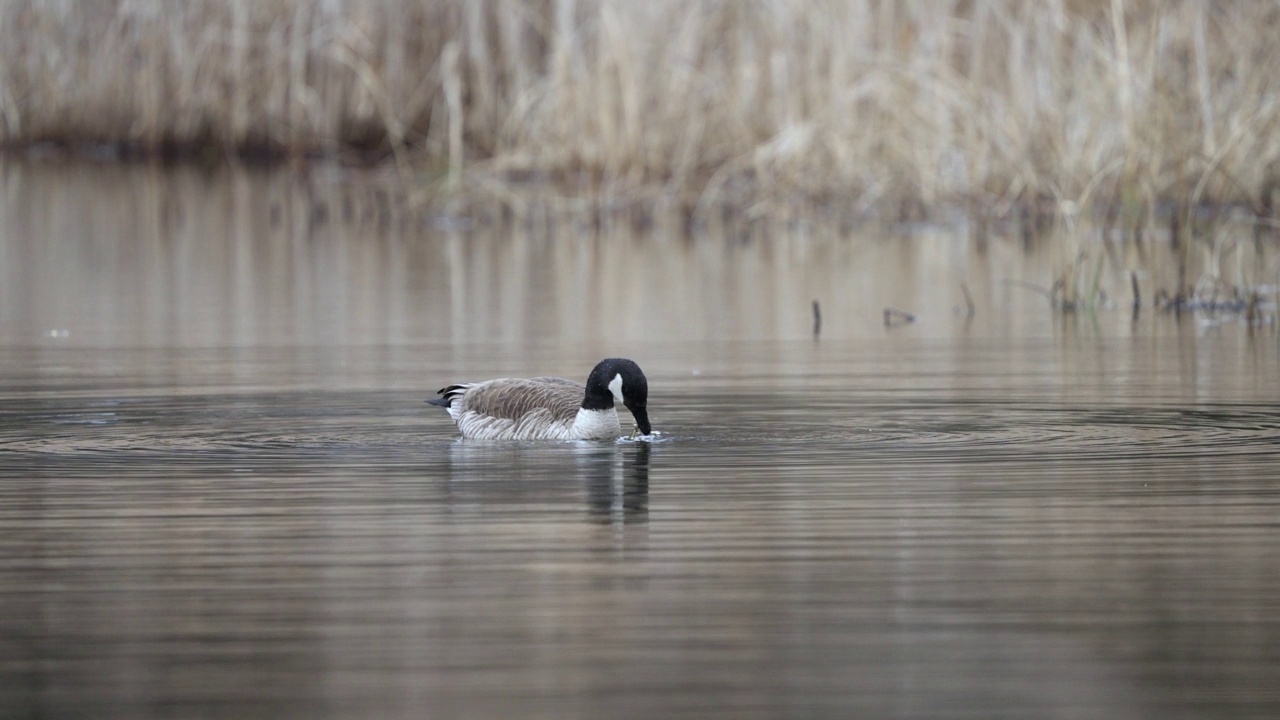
428;357;650;439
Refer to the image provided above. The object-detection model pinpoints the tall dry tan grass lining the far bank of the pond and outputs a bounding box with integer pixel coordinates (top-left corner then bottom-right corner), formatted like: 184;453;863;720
0;0;1280;211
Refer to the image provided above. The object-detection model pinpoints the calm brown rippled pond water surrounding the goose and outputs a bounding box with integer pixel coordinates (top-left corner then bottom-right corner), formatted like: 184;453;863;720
0;165;1280;719
